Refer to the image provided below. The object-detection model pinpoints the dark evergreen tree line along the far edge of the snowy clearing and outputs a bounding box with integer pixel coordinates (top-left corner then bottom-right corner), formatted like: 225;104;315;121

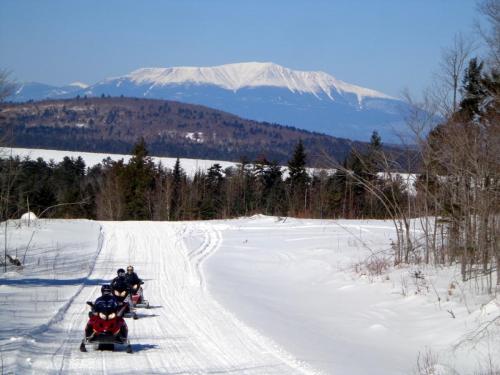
0;132;407;225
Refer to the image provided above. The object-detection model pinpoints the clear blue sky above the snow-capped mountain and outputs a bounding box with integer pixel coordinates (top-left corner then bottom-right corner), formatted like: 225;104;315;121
0;0;477;96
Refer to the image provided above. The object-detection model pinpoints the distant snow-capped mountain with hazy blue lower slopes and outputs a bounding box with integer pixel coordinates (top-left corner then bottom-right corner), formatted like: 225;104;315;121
11;62;408;143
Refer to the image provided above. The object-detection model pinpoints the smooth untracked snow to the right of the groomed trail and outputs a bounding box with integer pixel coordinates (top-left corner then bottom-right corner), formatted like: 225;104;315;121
206;216;500;375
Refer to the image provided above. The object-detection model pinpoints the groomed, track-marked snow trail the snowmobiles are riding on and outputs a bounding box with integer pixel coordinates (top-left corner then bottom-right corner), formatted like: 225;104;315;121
27;222;317;374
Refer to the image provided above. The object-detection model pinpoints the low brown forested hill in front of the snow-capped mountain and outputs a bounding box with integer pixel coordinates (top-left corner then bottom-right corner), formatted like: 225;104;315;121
0;97;368;165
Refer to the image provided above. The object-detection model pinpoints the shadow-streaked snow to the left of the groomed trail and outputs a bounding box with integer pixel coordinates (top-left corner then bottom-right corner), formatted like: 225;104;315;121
0;219;101;374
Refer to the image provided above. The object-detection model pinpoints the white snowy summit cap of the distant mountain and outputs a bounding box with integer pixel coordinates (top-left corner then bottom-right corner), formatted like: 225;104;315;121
109;62;392;100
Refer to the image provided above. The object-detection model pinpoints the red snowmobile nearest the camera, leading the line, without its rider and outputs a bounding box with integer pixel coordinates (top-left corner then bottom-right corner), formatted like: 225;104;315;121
80;302;132;353
